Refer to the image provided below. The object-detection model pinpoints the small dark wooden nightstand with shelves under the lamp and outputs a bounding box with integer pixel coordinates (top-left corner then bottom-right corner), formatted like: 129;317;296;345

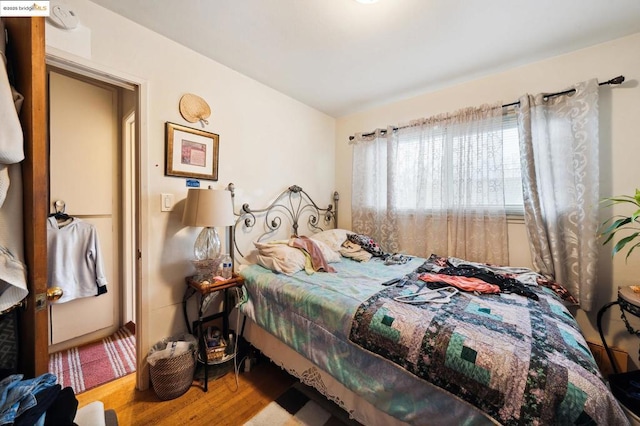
182;274;244;392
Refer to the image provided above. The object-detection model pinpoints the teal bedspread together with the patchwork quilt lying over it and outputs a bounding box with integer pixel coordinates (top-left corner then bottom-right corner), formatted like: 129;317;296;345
241;258;626;425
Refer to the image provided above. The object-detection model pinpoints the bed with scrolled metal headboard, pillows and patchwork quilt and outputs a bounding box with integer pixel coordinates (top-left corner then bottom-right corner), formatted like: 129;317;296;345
233;185;628;425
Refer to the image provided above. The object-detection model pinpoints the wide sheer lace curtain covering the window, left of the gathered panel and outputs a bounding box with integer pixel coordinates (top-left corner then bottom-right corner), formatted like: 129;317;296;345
352;104;509;264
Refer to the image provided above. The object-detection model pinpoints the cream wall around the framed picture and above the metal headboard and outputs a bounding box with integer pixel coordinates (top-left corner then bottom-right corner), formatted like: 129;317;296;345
47;0;335;382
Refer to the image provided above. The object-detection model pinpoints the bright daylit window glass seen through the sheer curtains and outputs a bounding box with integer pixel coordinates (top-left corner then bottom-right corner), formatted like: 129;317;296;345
366;112;524;216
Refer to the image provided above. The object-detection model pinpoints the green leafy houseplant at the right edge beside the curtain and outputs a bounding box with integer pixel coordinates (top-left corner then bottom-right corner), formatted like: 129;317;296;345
600;189;640;261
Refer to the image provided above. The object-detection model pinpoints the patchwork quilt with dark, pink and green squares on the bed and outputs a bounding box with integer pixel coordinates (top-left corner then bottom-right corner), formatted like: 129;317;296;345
349;274;626;425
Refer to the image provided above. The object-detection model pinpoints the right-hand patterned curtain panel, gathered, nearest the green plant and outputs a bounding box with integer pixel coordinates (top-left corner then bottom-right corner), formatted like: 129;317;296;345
518;80;599;311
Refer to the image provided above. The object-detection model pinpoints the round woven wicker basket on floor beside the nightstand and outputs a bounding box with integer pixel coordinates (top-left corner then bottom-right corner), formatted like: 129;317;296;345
149;350;196;401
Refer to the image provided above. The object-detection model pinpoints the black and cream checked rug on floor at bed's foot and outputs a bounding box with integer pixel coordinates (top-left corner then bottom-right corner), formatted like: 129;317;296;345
245;383;360;426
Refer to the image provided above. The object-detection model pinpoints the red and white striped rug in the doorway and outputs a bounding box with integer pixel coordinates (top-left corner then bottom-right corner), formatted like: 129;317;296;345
49;326;136;394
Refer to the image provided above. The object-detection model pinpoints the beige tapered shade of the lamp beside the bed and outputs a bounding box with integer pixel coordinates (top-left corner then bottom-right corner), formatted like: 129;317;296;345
182;188;235;227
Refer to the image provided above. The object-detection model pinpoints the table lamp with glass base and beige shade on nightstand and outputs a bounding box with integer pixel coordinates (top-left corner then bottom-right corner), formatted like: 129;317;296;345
182;187;235;272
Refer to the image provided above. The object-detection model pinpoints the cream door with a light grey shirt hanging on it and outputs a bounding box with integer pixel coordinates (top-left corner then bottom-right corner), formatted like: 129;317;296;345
49;71;121;352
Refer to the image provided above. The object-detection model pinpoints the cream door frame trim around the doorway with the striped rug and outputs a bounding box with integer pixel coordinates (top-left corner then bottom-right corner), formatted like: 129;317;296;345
45;47;149;390
